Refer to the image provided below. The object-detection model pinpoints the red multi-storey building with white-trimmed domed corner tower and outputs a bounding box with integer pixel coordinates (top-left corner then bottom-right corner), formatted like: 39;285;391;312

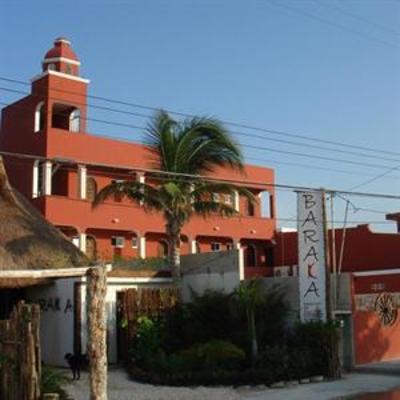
0;38;276;276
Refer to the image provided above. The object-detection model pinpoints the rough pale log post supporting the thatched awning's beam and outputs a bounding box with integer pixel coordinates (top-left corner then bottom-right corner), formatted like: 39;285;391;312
86;267;107;400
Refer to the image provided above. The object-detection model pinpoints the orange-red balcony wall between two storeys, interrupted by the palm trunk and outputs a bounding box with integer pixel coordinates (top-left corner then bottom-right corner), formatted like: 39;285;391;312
33;196;276;239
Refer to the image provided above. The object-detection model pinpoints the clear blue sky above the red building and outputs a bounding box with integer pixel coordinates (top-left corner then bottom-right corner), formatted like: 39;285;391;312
0;0;400;230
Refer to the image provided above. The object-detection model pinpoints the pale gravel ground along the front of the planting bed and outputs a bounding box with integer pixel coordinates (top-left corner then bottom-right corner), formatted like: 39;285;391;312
65;369;400;400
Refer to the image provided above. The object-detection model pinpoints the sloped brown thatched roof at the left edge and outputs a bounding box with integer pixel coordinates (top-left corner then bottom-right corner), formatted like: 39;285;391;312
0;156;89;288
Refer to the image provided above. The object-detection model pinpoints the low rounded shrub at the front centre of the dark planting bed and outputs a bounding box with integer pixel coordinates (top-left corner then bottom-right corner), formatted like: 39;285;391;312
180;340;246;371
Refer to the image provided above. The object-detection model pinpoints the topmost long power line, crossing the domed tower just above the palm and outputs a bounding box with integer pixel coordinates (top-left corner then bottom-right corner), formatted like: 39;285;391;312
0;76;400;156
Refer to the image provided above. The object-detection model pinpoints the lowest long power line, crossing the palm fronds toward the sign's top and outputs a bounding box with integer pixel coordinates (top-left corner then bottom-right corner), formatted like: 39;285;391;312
0;151;400;200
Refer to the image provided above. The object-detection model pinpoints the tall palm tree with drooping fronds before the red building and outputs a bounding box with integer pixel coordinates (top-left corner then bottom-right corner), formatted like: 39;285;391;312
94;111;254;284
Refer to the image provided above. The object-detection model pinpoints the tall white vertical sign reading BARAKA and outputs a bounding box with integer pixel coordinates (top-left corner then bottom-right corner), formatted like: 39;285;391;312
297;191;327;322
